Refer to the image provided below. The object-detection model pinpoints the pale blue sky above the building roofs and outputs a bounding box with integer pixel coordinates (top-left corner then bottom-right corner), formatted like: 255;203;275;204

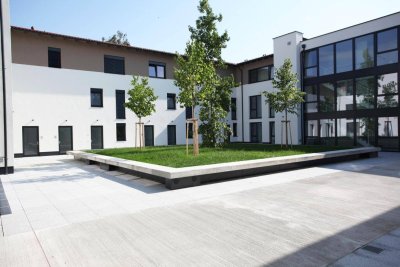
9;0;400;63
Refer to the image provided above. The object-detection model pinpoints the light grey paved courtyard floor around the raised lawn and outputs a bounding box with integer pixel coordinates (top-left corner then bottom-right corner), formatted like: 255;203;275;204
0;153;400;266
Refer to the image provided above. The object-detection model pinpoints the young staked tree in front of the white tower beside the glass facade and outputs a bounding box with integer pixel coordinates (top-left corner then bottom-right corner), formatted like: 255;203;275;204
263;59;305;147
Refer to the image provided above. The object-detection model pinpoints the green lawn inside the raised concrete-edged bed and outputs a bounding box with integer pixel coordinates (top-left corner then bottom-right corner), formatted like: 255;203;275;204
88;144;346;168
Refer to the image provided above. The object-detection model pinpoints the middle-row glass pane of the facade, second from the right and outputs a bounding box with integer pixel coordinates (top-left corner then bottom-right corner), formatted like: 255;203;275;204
356;76;375;109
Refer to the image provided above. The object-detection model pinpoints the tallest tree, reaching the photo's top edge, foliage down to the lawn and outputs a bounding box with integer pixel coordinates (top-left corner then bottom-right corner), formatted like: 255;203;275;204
189;0;235;147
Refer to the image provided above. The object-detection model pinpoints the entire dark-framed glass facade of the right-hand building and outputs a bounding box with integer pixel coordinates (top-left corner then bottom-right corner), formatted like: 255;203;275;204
303;27;400;151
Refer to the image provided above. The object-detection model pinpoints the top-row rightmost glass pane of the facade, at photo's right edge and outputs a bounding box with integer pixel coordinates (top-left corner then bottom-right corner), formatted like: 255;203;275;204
376;29;398;66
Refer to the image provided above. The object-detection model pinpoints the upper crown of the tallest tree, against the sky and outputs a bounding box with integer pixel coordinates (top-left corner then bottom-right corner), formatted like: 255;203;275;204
189;0;229;67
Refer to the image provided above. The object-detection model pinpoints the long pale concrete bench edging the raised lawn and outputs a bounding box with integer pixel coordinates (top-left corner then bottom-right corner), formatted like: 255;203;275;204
67;147;380;189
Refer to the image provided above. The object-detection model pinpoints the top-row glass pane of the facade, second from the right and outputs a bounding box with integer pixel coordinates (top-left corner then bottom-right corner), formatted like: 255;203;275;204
355;34;374;69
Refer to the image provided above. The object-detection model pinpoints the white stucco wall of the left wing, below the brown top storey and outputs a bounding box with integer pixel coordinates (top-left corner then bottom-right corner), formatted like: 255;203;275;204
12;64;191;153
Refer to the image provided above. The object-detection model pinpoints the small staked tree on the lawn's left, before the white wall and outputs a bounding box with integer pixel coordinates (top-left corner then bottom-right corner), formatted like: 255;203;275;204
125;76;158;148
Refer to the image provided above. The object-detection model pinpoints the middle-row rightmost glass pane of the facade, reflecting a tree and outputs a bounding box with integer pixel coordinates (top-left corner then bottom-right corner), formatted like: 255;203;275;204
377;73;399;108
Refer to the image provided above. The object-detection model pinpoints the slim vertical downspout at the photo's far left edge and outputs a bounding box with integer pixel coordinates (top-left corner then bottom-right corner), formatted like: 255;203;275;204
0;4;8;174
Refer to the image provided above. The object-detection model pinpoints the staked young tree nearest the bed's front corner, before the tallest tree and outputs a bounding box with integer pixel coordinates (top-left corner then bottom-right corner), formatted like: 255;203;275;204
174;41;215;156
